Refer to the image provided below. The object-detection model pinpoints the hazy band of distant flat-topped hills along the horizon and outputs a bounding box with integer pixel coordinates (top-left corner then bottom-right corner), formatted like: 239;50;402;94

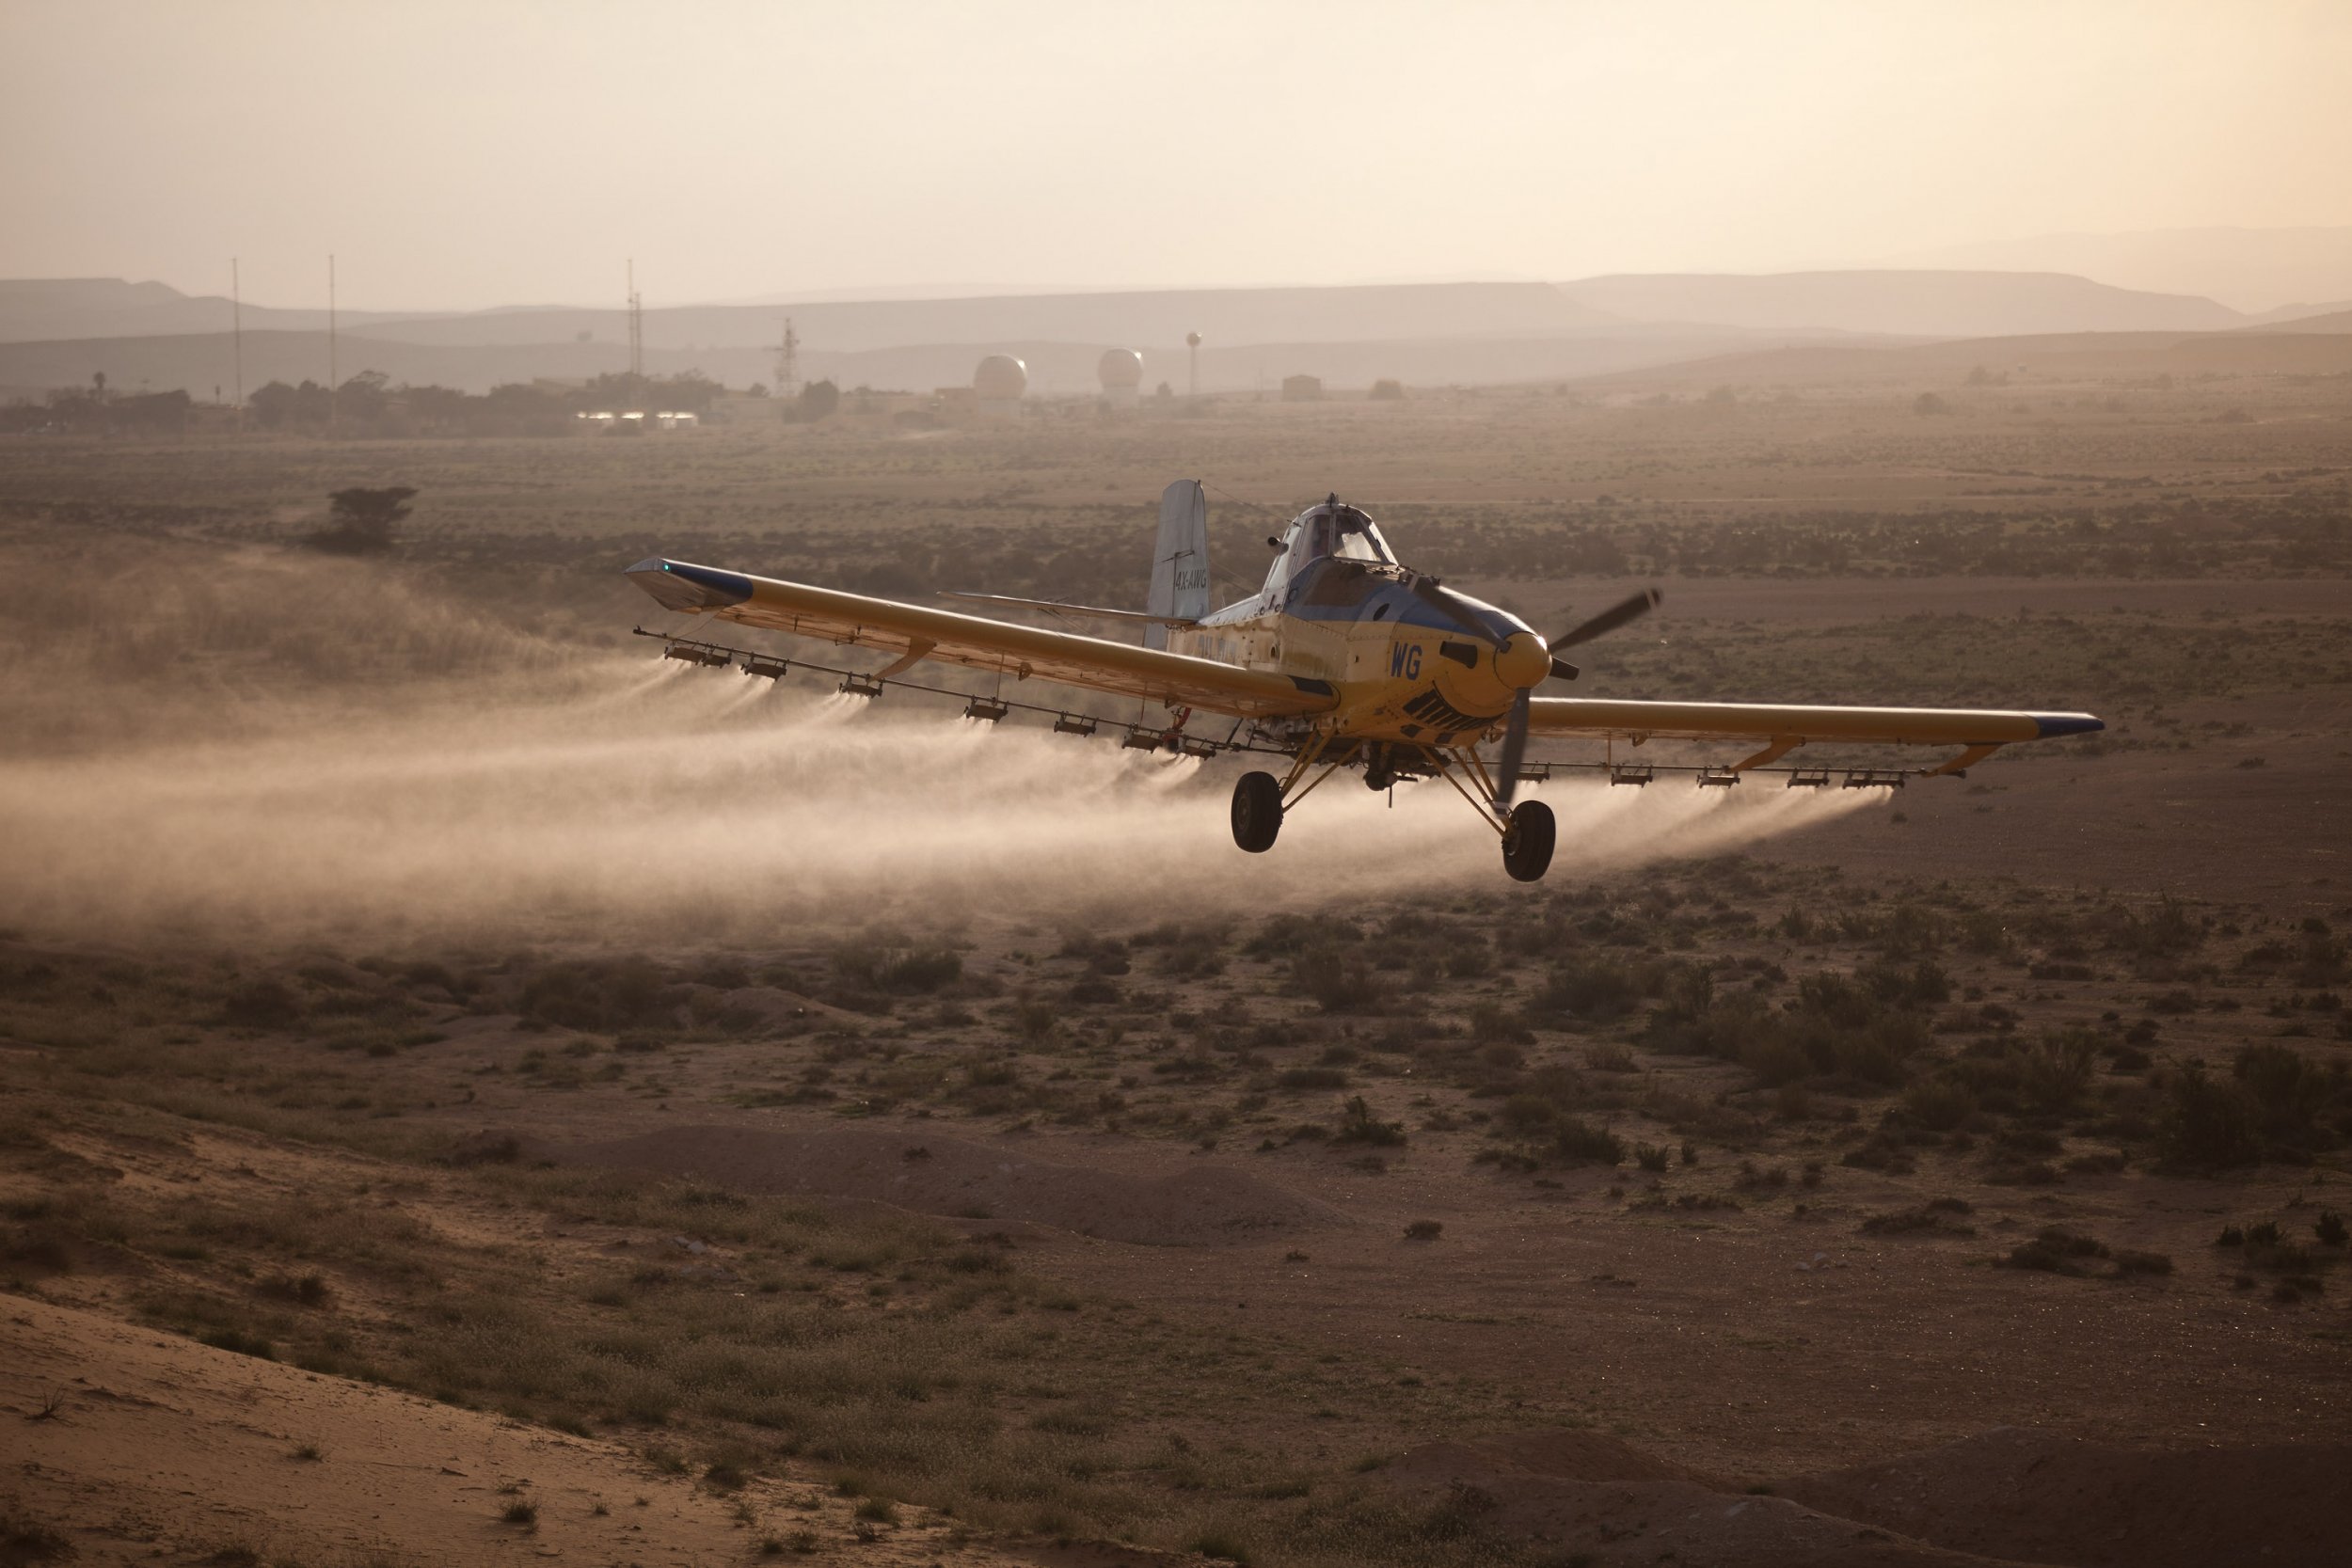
0;270;2352;397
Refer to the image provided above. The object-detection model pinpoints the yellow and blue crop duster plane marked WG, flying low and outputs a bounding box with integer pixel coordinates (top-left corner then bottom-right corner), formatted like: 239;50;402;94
628;480;2106;881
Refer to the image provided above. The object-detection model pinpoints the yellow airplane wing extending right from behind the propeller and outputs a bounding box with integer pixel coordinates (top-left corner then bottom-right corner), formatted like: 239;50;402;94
1527;696;2107;767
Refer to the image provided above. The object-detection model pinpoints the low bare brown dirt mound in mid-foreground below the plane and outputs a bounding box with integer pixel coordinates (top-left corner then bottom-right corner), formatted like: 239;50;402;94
541;1126;1348;1246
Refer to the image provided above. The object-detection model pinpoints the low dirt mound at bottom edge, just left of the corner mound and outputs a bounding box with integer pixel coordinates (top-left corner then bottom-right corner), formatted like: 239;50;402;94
1388;1432;1988;1568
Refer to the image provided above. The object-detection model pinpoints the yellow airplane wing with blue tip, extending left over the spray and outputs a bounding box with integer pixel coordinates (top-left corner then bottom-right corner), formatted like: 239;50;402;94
628;555;1339;720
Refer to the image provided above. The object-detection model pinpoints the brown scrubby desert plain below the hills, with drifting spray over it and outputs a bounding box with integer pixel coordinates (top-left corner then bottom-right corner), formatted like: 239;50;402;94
0;359;2352;1568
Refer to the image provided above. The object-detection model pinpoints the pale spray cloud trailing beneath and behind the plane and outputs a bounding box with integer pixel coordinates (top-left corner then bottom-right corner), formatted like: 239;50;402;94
0;654;1866;942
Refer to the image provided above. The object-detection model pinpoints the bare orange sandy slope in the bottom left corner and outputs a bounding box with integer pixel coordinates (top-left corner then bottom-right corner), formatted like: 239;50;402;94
0;1295;1028;1568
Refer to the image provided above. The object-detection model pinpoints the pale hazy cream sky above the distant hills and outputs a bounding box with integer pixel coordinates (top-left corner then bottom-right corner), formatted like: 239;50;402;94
0;0;2352;308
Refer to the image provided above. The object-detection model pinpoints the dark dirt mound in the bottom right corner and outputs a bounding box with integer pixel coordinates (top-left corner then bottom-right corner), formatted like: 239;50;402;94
1773;1427;2352;1568
